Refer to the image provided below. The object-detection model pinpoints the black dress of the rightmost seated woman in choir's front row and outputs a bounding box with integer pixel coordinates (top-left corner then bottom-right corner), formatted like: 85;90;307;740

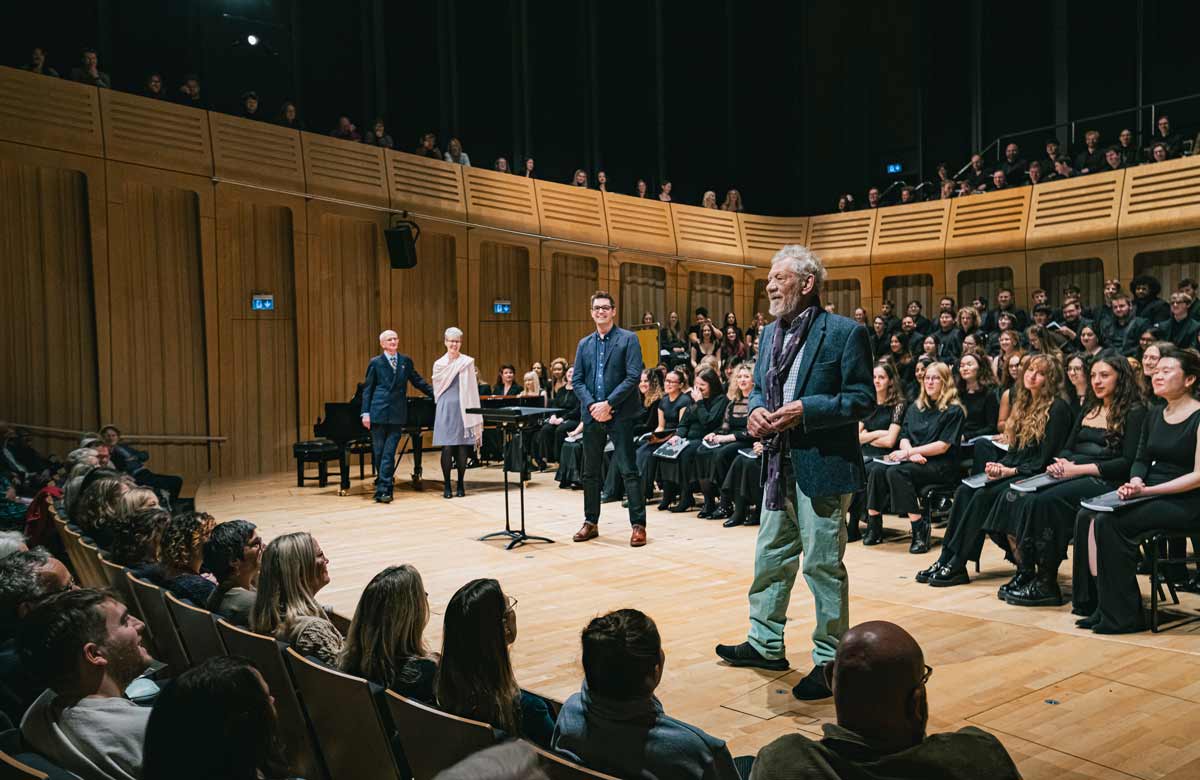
1074;407;1200;634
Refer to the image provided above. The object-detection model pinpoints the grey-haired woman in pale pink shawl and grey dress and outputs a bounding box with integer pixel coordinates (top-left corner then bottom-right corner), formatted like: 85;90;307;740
433;328;484;498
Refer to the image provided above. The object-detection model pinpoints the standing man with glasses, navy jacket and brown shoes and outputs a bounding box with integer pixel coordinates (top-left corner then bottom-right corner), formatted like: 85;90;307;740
575;290;646;547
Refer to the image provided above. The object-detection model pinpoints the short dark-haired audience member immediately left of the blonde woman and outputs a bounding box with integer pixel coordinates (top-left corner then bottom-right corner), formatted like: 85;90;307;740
197;520;263;629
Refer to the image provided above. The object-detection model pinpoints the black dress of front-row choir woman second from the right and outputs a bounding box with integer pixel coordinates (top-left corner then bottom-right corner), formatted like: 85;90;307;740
1008;406;1146;571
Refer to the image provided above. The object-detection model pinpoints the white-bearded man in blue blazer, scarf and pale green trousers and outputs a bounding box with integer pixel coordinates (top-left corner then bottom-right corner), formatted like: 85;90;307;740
716;245;875;700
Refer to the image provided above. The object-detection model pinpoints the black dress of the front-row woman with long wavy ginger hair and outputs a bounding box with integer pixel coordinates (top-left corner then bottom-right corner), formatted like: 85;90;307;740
938;398;1074;571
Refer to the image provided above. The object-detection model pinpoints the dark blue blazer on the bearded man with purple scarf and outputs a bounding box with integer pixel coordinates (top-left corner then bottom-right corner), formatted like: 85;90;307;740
750;311;875;498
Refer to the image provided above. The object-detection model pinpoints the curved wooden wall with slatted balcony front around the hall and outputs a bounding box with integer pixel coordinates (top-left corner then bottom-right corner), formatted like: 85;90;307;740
7;67;1200;476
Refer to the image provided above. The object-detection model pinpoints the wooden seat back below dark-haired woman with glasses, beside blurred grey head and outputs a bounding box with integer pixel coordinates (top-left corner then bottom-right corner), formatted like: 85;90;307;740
384;690;496;780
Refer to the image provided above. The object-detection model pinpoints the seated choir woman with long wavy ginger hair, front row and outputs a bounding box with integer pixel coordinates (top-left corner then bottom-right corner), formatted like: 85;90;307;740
917;355;1074;588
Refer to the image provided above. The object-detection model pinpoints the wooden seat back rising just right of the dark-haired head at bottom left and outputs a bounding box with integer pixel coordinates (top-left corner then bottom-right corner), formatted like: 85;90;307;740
217;618;329;780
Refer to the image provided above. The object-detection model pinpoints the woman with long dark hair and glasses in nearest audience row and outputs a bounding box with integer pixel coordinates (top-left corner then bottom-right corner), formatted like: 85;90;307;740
436;580;554;748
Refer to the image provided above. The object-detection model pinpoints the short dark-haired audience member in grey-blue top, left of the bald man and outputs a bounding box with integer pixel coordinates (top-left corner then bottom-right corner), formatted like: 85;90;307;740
553;610;740;780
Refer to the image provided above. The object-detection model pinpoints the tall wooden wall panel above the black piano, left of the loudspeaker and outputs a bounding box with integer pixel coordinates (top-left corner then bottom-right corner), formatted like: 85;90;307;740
296;202;388;438
